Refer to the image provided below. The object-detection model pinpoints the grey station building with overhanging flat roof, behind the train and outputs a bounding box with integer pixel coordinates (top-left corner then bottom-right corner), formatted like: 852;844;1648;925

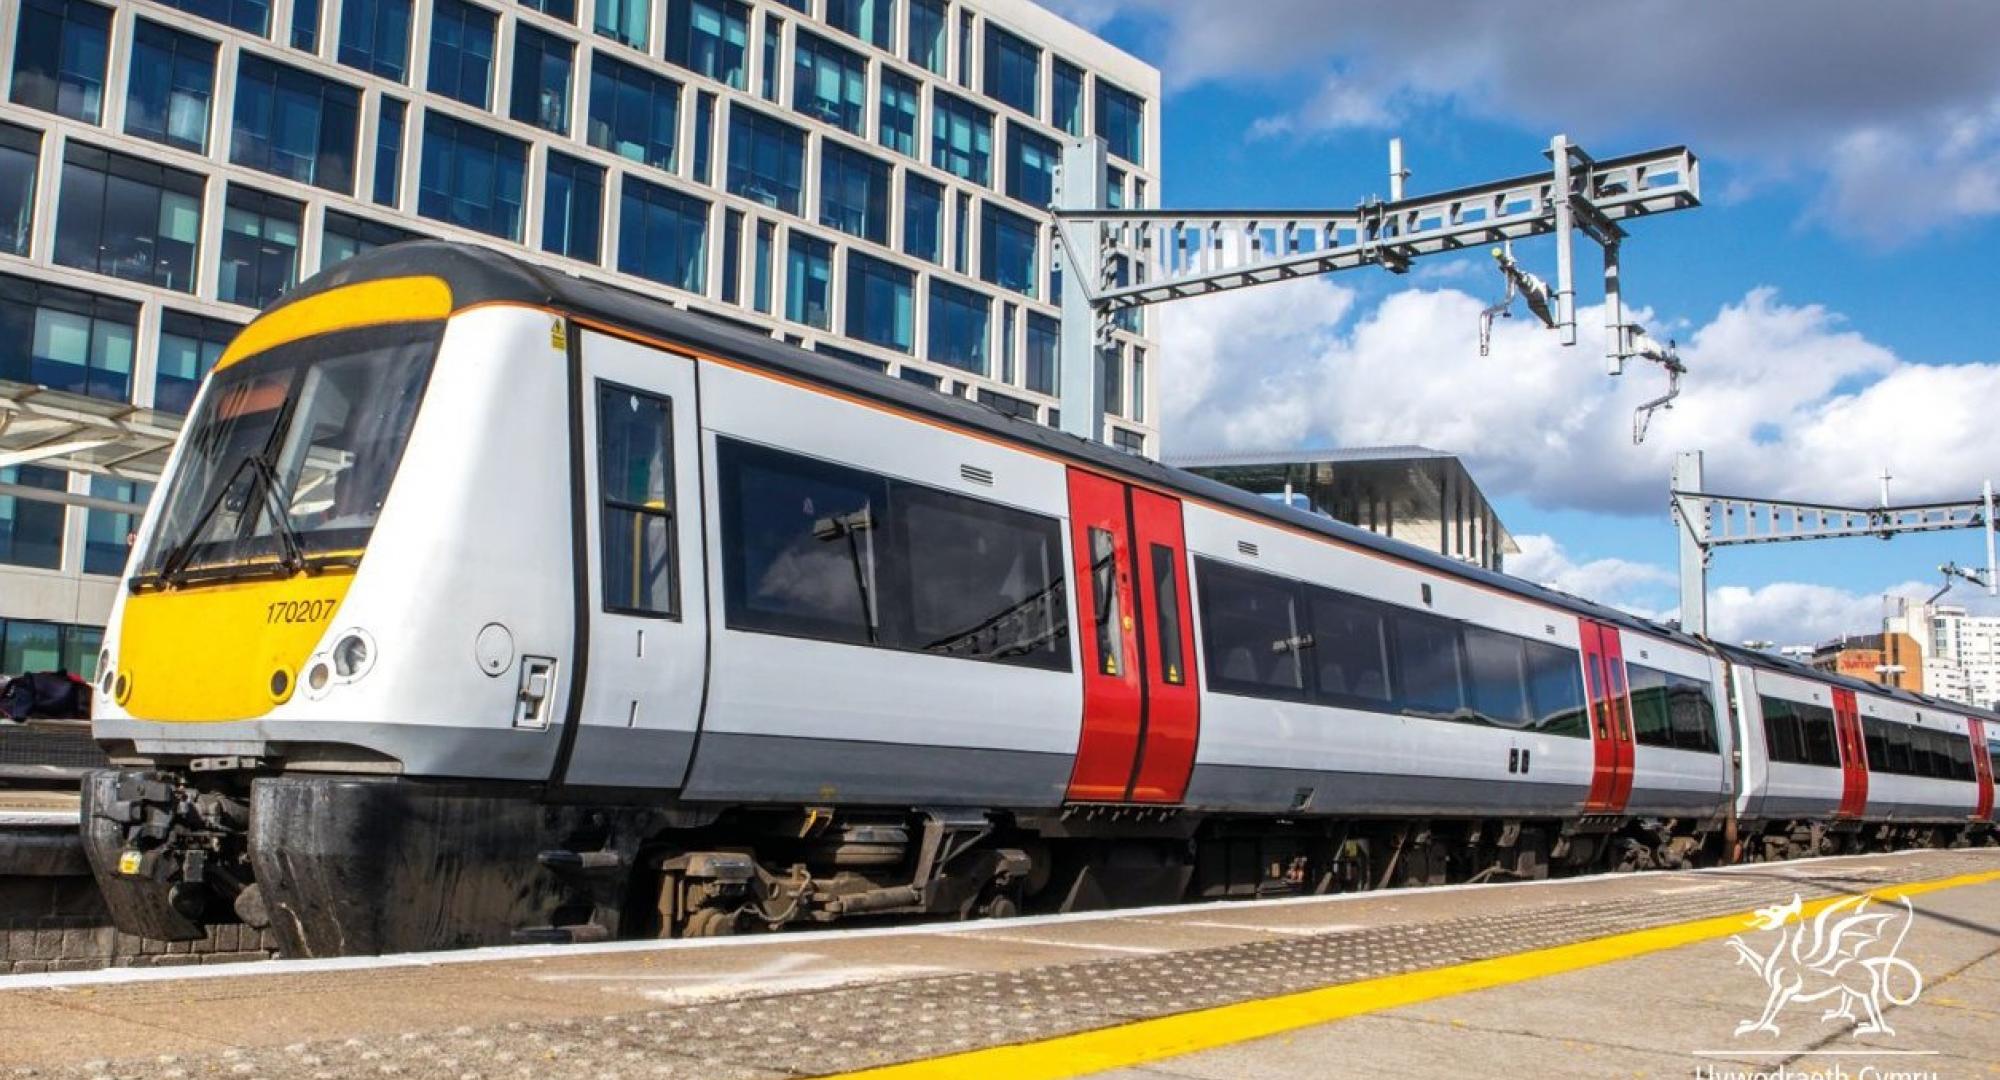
1166;446;1520;570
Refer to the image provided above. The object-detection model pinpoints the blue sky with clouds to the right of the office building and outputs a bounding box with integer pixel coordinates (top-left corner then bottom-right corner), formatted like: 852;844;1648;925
1052;0;2000;642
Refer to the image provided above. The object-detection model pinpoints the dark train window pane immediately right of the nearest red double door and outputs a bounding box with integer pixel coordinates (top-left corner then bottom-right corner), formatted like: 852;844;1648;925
1200;560;1314;700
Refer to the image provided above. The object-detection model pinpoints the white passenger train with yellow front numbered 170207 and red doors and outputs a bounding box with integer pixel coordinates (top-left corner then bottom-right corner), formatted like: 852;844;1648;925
84;242;2000;956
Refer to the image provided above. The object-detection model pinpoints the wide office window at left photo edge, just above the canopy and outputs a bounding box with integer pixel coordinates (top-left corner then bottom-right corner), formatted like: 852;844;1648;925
0;278;138;402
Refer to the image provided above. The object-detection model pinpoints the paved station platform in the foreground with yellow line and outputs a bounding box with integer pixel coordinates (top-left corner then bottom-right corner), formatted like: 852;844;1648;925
0;848;2000;1080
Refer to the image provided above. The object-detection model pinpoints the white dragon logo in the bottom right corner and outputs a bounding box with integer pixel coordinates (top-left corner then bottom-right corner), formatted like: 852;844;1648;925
1730;894;1924;1036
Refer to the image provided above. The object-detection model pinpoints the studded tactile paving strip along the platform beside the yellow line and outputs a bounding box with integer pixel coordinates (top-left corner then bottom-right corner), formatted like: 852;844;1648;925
35;852;1994;1080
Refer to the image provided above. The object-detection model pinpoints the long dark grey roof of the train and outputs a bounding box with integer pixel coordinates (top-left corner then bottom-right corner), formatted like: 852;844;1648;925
274;240;1882;692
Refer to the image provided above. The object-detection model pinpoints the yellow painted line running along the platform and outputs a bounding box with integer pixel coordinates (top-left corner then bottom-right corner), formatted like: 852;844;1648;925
838;870;2000;1080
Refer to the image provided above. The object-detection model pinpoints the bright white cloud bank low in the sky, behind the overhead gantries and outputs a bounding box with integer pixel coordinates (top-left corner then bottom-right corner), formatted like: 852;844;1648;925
1160;278;2000;516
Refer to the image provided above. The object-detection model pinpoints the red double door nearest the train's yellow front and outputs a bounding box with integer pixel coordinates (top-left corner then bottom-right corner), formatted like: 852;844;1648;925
1068;470;1200;802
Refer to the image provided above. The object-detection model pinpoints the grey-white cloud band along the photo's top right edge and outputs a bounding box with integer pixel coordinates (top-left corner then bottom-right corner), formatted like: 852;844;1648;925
1054;0;2000;242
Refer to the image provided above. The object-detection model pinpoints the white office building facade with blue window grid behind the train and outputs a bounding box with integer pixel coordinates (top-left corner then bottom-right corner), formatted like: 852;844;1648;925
0;0;1160;674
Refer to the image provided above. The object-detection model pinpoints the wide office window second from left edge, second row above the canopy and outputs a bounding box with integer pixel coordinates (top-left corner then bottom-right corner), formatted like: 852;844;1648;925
56;142;202;292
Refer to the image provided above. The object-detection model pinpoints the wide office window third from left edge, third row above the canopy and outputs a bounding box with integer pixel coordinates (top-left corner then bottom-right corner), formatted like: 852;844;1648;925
230;52;362;192
